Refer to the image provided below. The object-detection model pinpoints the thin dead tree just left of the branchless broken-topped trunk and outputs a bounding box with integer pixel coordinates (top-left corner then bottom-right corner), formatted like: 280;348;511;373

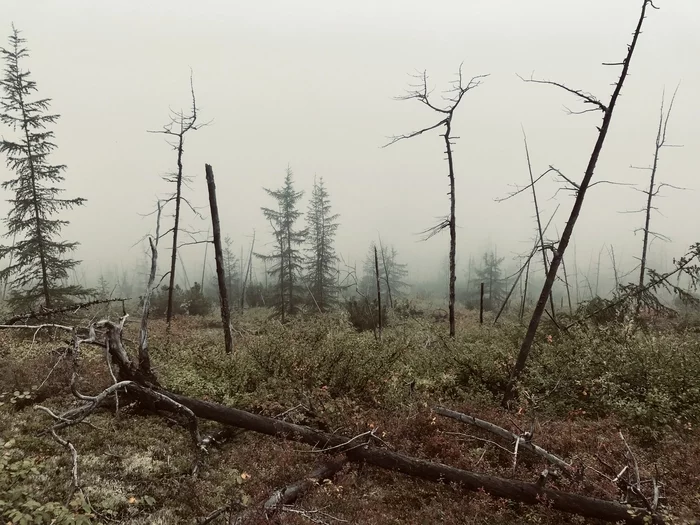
149;73;199;325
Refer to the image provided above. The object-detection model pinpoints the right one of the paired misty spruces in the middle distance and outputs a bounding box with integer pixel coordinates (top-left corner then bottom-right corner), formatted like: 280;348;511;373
306;177;339;312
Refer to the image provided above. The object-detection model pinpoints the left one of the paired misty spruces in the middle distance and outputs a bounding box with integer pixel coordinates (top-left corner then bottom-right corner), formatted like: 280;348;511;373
258;168;306;322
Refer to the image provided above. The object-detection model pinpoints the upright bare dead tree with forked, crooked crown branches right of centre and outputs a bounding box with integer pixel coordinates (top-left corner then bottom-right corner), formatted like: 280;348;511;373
384;65;488;337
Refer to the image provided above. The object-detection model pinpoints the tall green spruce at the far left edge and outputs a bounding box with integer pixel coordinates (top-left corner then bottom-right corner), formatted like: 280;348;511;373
0;26;91;310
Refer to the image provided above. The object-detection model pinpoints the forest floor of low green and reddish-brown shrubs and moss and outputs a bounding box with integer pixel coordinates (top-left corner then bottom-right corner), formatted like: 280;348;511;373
0;304;700;524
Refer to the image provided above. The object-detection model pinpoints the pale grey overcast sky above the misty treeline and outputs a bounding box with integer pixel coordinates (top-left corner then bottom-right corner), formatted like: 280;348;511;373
0;0;700;290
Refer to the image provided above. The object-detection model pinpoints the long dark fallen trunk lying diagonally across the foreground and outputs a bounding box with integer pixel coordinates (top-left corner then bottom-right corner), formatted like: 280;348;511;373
160;390;680;525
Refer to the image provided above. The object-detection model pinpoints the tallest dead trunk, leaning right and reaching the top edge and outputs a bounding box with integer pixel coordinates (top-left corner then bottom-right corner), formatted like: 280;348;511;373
501;0;655;407
